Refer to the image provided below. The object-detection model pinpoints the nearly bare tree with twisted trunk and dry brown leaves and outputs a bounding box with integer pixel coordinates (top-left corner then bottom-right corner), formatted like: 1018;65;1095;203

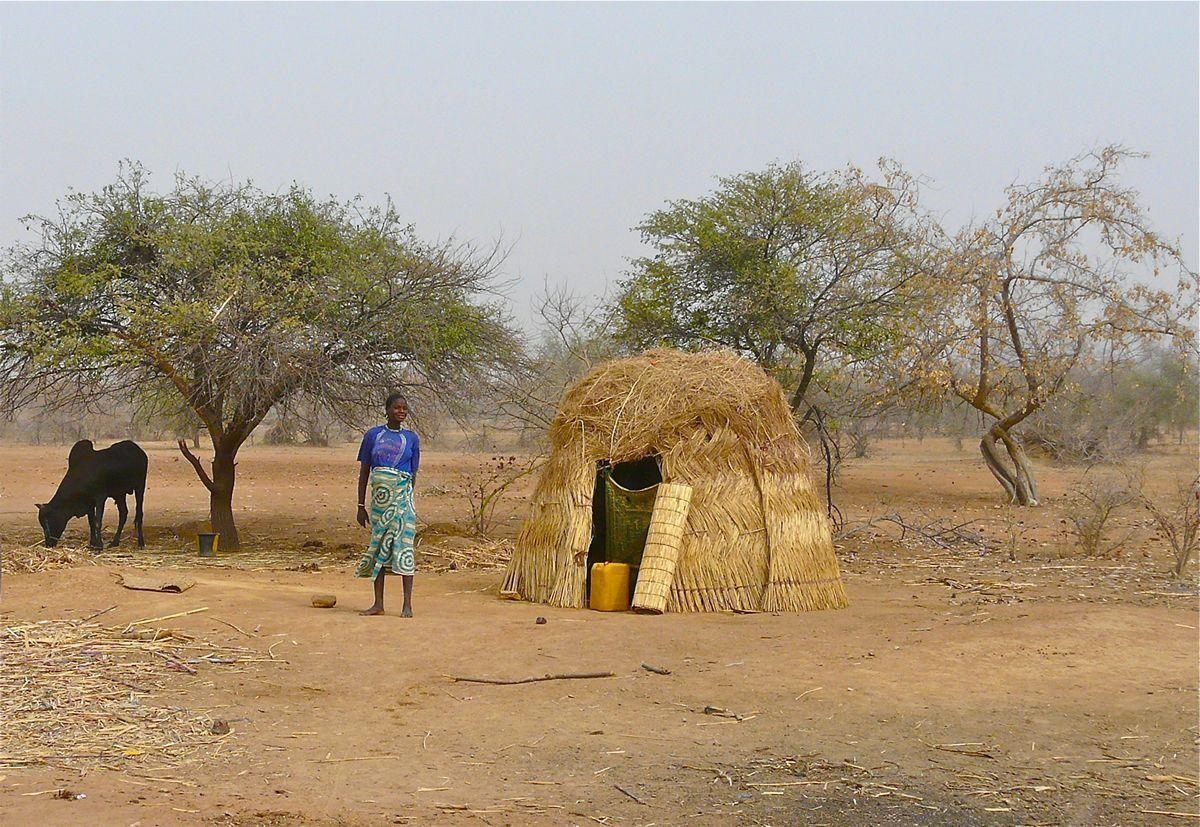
928;146;1196;505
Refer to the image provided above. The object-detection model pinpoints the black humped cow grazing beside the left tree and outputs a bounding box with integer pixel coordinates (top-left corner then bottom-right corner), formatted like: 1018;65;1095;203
37;439;146;549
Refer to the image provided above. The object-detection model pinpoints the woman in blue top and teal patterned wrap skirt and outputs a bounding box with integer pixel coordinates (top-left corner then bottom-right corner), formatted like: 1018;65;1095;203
354;394;421;617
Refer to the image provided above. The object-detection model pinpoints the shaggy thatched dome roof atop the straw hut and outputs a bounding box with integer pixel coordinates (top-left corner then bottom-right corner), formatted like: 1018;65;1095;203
550;349;806;467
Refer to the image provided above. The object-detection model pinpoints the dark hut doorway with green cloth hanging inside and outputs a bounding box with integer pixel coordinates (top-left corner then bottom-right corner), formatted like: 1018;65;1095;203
587;455;662;593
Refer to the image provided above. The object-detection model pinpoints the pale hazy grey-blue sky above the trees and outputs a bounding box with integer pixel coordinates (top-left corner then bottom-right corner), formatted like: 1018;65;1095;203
0;2;1200;317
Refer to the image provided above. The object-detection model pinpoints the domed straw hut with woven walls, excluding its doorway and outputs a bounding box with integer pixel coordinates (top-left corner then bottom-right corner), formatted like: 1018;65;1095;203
502;349;846;611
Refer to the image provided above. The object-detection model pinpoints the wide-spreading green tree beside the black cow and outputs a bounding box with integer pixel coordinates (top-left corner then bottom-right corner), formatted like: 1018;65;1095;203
0;164;516;549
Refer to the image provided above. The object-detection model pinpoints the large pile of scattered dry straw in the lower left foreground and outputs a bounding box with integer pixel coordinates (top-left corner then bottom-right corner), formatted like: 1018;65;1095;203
0;621;270;772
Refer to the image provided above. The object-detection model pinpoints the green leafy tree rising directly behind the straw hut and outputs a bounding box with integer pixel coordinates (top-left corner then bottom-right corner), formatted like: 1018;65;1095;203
613;161;930;508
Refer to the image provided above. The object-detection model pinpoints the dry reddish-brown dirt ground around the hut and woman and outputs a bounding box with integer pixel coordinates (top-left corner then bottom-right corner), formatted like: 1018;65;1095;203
0;439;1200;827
